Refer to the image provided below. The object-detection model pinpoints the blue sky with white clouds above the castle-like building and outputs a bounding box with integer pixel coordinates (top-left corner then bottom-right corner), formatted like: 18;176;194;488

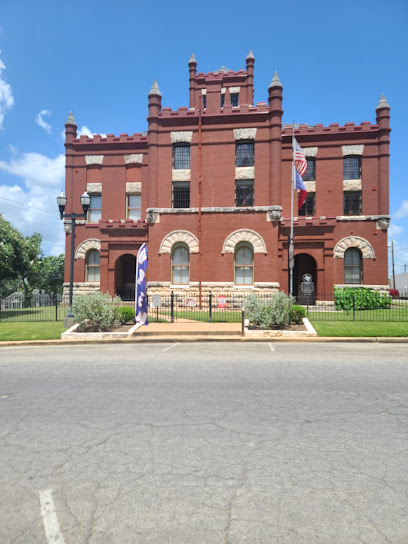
0;0;408;272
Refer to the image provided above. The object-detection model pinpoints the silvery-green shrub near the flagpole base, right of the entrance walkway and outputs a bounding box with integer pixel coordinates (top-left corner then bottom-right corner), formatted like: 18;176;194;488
245;291;294;329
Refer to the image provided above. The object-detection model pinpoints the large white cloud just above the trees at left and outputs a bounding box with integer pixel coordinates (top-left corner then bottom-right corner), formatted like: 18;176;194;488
0;153;65;255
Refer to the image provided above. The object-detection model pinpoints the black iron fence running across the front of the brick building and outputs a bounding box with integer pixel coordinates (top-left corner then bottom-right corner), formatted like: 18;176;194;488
0;292;408;324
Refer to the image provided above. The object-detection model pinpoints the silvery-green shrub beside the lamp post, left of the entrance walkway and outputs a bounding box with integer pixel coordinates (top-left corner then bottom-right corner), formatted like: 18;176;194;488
72;293;120;332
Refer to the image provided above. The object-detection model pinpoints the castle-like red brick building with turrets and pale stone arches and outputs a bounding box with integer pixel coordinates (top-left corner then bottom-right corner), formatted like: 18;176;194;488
65;51;390;298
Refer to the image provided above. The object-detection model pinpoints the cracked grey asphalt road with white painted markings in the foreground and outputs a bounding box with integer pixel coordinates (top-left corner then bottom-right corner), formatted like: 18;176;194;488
0;343;408;544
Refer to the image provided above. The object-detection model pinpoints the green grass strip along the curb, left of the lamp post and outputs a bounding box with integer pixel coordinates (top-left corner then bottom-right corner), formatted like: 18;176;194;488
0;321;65;342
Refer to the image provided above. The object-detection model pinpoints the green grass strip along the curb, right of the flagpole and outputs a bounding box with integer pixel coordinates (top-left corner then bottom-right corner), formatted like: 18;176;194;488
310;319;408;336
